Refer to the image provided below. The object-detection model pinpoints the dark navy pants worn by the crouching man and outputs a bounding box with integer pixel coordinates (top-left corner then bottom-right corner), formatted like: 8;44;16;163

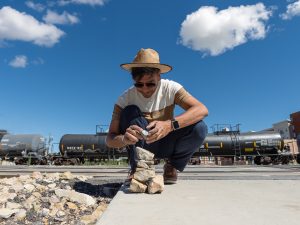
120;105;207;171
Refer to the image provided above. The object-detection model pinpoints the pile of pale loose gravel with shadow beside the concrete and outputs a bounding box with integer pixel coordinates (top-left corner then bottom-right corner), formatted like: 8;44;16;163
0;172;122;225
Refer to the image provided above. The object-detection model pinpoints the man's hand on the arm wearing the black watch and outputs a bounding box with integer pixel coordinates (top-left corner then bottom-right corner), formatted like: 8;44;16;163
146;120;172;144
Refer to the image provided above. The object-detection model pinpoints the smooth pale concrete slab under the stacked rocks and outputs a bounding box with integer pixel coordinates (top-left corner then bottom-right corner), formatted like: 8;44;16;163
97;180;300;225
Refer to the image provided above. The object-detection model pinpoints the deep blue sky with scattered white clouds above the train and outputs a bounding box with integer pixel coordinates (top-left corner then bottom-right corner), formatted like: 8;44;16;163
0;0;300;151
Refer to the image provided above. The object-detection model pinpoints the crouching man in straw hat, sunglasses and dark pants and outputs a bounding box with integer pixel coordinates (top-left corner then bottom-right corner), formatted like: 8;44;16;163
106;49;208;184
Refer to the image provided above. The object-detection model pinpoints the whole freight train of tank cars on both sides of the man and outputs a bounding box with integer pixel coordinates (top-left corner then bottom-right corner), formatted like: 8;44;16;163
0;130;300;165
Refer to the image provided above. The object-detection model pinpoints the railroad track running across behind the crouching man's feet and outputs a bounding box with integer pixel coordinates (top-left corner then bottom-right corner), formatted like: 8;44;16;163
0;165;300;180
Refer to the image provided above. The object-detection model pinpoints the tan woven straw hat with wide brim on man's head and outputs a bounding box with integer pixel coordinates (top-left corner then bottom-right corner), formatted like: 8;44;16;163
121;48;172;73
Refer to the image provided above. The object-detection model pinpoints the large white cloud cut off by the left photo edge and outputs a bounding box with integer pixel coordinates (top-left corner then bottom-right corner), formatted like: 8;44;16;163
0;6;64;47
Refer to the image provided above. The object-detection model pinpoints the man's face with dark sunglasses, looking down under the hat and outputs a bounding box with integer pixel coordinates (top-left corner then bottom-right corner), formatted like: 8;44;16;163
134;73;160;98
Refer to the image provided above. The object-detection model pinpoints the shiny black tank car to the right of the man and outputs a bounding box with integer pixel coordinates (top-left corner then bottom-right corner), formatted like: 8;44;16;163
194;130;300;165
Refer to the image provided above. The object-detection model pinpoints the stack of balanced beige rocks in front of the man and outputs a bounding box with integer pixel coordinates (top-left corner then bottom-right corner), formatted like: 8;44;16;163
129;147;164;194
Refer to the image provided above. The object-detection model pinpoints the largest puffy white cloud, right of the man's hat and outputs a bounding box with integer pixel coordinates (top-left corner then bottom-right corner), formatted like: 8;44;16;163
179;3;272;56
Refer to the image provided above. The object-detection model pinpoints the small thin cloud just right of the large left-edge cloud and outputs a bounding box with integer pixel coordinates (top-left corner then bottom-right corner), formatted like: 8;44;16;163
43;10;79;24
